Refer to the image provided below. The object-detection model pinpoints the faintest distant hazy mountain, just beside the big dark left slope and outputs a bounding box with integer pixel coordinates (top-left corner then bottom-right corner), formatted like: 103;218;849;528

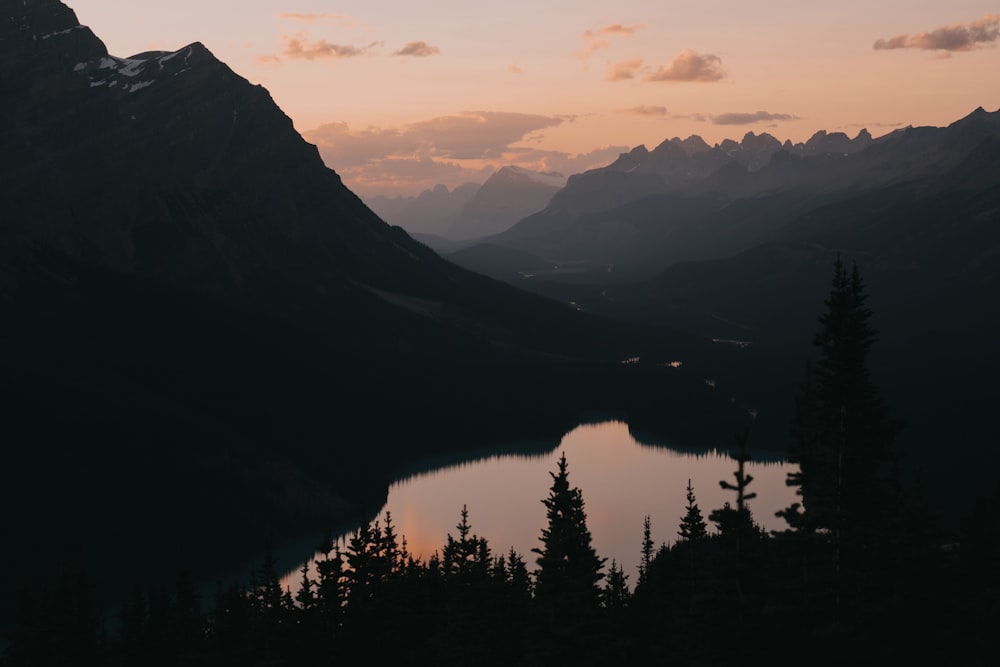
365;183;480;236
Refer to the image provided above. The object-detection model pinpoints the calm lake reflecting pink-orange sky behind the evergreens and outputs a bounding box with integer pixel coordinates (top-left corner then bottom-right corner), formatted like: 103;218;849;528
283;421;794;591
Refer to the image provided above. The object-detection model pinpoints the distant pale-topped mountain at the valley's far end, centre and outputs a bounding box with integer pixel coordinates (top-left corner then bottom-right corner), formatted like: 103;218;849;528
446;166;566;240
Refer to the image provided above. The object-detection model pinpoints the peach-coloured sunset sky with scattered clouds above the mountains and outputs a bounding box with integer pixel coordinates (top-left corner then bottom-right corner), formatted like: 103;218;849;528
66;0;1000;197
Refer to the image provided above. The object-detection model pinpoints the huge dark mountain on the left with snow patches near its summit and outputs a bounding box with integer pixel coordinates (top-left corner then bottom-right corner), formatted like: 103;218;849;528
0;0;735;627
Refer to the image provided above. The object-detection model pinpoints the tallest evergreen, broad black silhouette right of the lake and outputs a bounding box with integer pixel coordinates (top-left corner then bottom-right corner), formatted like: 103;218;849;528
779;256;899;567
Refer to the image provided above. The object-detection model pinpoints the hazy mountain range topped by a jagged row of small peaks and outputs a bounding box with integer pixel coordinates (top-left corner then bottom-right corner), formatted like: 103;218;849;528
458;130;873;282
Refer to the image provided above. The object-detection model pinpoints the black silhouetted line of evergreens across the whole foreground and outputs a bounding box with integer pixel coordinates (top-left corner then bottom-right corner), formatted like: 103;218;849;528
2;259;1000;667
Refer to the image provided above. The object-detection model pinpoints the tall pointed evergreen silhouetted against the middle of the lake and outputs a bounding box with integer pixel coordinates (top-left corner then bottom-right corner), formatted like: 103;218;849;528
532;454;605;616
